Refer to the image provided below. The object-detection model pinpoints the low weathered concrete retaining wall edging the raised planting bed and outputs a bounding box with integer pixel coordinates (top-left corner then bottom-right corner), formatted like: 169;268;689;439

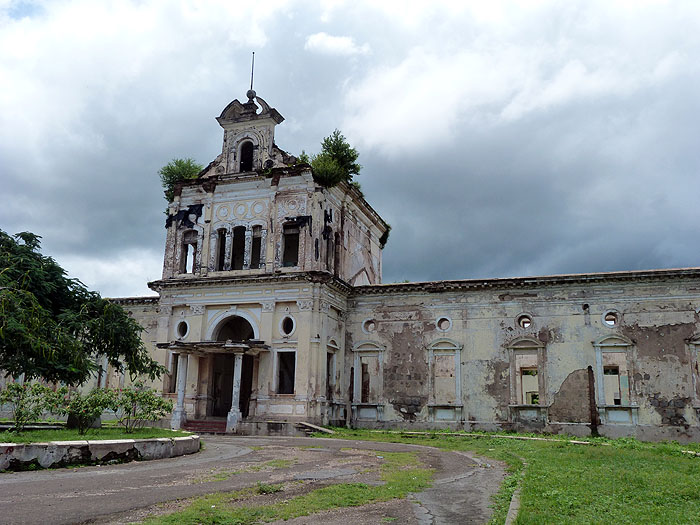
0;436;199;470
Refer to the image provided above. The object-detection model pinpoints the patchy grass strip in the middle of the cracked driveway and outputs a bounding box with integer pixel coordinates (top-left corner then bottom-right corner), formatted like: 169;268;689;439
145;452;433;525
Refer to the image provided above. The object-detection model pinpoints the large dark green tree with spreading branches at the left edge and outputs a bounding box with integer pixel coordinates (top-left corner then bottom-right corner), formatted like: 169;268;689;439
0;230;164;385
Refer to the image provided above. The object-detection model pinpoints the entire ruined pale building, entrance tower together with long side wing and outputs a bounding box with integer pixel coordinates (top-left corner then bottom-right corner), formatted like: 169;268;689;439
119;91;700;440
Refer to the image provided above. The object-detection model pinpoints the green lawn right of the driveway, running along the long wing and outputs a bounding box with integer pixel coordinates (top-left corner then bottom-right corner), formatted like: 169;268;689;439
324;430;700;524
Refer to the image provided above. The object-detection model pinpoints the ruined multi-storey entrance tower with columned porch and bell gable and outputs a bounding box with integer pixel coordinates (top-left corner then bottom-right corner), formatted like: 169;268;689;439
150;90;388;432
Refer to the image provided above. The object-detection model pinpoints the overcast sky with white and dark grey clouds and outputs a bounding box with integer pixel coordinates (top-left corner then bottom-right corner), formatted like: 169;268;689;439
0;0;700;297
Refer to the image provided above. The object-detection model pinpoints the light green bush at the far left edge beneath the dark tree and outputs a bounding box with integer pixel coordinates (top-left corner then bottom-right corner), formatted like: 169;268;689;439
0;383;65;432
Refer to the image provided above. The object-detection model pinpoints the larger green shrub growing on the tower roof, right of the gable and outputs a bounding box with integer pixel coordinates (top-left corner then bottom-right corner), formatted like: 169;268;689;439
311;129;362;187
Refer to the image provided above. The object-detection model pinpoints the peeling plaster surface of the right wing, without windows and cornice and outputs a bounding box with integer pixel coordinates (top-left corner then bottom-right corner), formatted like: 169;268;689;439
346;279;700;438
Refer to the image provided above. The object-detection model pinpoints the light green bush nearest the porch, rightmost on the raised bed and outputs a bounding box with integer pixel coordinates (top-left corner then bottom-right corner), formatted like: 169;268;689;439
115;381;173;433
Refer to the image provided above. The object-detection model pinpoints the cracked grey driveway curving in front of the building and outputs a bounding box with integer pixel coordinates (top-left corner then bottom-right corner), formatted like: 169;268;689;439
0;437;504;525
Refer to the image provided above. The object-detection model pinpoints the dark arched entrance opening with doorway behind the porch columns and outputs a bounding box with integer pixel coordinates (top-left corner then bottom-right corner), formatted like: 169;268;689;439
208;315;255;417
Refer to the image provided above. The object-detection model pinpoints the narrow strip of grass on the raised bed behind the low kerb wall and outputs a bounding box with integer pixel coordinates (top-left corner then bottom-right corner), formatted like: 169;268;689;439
0;427;192;443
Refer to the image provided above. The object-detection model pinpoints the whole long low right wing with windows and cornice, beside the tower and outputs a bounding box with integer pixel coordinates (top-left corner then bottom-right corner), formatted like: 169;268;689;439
345;270;700;440
